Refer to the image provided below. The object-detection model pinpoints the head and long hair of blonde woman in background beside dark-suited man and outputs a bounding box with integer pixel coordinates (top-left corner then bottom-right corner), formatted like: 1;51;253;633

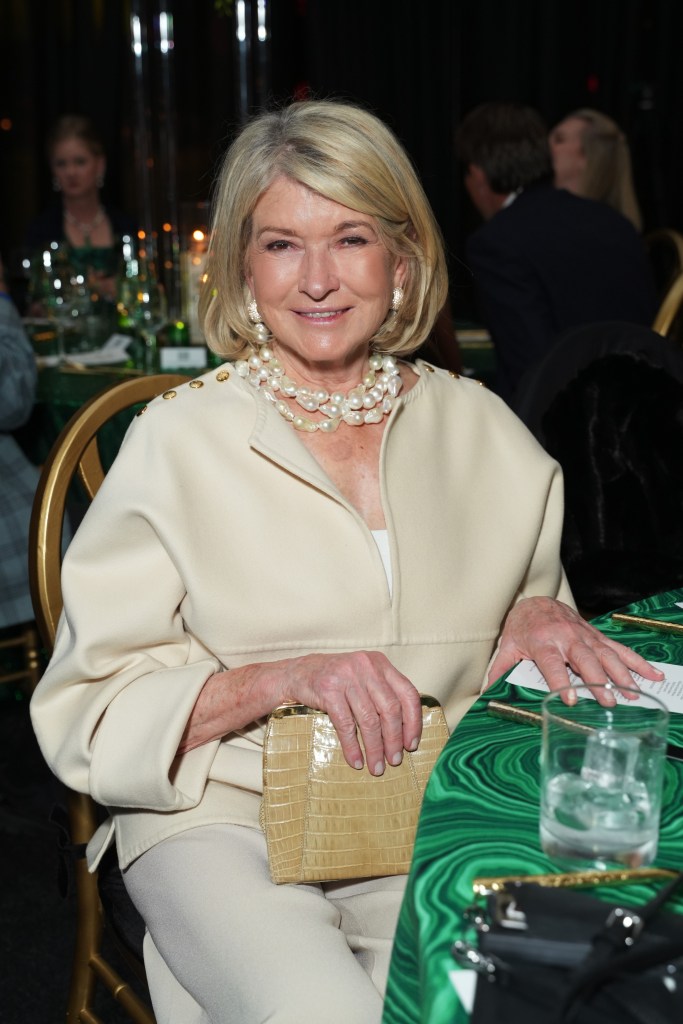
550;109;642;231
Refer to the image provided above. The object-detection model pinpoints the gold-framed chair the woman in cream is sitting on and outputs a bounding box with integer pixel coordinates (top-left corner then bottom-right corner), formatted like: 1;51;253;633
29;374;188;1024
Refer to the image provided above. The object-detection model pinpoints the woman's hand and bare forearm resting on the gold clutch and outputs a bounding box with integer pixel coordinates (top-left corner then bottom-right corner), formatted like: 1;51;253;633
178;650;422;775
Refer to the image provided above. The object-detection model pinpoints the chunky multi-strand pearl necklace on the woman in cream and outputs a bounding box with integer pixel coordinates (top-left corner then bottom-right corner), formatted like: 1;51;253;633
234;344;403;433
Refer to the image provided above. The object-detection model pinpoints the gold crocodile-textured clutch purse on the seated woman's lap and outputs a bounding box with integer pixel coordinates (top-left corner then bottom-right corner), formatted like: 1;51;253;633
261;696;449;884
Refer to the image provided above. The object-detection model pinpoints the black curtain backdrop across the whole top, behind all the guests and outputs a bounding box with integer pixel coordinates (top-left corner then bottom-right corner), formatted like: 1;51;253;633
0;0;683;312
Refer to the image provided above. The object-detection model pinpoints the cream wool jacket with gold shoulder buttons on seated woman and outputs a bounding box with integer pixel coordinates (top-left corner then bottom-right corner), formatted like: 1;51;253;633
32;361;571;866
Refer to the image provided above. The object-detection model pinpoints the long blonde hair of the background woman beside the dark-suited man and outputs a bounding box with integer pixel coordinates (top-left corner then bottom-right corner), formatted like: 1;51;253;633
564;108;642;231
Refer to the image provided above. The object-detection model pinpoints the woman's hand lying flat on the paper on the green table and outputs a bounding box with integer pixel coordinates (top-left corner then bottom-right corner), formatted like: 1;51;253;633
486;597;664;702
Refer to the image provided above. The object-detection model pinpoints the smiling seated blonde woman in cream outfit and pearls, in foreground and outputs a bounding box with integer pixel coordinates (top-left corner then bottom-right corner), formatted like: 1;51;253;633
32;101;653;1024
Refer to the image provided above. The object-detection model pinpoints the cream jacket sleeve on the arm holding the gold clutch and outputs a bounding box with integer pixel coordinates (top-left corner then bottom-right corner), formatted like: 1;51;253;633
31;419;221;811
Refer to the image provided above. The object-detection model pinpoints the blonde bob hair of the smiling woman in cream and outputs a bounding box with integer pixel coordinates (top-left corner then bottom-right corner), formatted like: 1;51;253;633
199;100;447;359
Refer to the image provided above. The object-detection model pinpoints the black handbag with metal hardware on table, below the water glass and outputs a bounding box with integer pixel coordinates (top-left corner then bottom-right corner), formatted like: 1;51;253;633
452;873;683;1024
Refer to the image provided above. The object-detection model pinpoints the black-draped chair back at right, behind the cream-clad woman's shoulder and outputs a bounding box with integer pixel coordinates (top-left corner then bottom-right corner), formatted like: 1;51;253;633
517;324;683;615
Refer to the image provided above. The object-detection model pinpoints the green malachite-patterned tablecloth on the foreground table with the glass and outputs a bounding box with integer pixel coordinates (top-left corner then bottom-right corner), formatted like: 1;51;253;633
383;590;683;1024
